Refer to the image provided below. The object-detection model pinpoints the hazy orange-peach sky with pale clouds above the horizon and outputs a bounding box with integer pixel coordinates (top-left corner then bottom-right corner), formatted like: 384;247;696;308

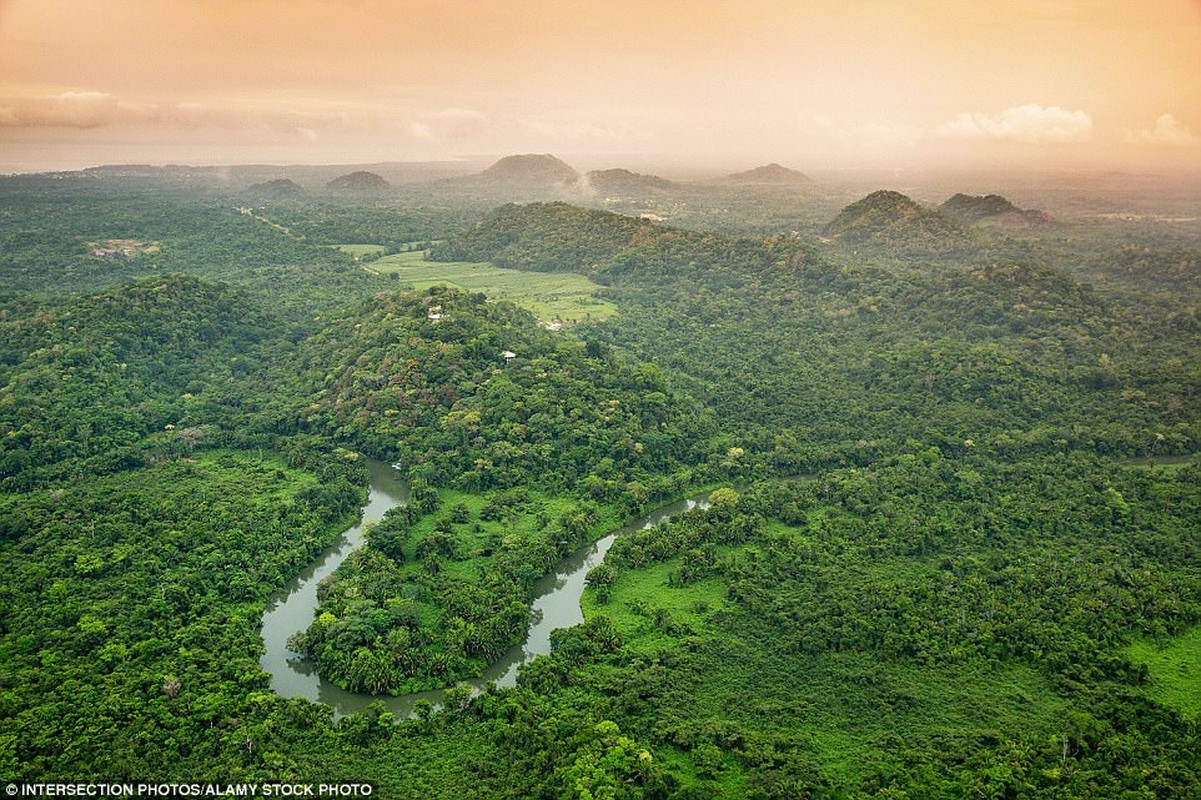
0;0;1201;172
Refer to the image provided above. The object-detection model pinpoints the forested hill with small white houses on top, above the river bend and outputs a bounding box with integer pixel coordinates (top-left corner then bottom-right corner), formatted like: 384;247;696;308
291;287;705;494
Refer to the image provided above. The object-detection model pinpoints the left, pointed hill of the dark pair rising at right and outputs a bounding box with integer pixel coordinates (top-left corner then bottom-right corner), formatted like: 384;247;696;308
825;190;970;255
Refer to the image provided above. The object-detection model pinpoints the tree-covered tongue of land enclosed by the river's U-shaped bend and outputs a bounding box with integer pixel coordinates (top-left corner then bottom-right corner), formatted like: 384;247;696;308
297;488;615;694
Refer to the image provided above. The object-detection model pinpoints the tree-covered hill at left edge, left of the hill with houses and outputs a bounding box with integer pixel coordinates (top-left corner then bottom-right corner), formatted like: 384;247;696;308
0;275;280;489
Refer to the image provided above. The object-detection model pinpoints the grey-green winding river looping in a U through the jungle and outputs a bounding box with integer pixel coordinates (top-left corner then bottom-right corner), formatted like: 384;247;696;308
258;460;707;718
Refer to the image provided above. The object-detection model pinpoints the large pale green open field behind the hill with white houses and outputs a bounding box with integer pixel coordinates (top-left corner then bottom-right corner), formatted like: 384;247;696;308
367;251;617;322
